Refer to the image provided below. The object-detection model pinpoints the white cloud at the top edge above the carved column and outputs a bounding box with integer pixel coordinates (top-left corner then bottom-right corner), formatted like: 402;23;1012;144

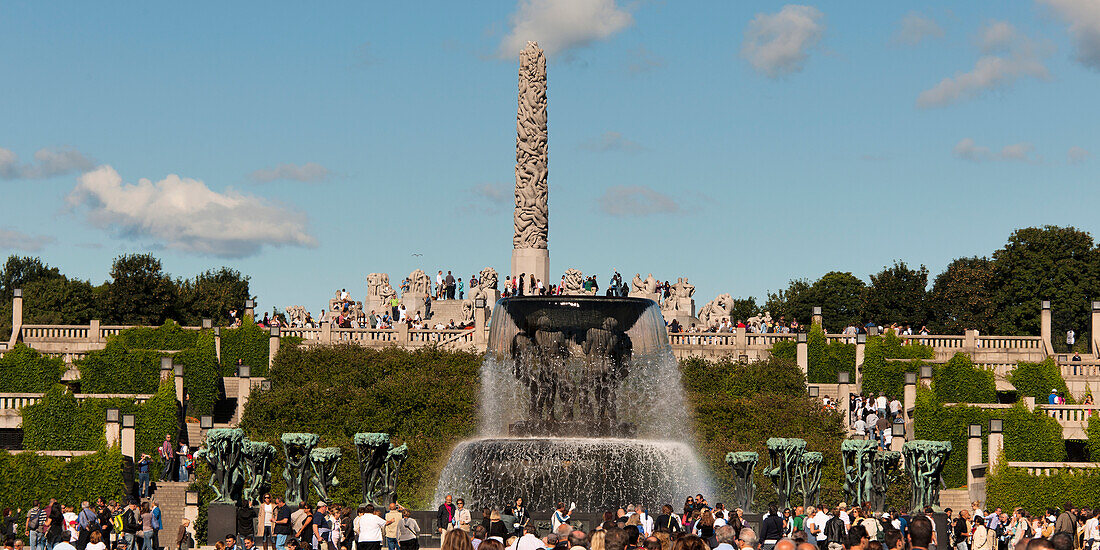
499;0;634;59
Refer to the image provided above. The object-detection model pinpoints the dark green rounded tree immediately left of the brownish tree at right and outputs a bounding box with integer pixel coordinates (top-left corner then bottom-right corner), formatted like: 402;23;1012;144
862;261;928;327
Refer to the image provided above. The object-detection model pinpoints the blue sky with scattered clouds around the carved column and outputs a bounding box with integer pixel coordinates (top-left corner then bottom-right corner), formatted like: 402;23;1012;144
0;0;1100;309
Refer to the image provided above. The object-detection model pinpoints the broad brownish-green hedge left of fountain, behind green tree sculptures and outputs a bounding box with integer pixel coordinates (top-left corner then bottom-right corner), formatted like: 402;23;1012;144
241;344;482;507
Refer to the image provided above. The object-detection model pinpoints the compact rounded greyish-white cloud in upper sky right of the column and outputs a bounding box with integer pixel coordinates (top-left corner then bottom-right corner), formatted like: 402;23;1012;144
741;4;825;78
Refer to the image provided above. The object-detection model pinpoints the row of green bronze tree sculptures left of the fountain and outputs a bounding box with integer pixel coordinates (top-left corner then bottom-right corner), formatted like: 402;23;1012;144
196;428;408;507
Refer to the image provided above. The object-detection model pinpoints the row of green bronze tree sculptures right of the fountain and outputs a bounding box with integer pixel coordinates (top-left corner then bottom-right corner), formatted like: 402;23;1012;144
726;438;952;512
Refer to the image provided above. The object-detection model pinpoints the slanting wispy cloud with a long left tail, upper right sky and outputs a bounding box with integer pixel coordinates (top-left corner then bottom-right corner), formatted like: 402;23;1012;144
916;22;1051;109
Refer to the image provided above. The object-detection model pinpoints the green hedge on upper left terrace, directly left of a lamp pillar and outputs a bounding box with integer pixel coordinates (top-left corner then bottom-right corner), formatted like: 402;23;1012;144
77;341;162;394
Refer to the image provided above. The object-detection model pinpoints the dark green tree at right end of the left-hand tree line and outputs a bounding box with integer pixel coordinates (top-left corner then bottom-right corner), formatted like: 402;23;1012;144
176;267;250;327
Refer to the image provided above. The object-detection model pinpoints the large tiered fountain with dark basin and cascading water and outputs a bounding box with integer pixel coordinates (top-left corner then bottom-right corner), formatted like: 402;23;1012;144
436;296;710;513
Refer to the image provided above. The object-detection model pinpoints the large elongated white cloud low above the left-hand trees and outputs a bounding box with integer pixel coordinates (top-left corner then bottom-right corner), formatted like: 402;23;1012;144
68;166;317;257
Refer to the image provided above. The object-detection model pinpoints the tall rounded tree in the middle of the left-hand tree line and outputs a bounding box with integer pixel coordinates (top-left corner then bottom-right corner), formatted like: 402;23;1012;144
106;254;176;327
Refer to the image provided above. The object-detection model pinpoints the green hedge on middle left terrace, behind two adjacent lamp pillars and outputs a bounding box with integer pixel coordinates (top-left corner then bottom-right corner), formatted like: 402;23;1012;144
22;382;178;459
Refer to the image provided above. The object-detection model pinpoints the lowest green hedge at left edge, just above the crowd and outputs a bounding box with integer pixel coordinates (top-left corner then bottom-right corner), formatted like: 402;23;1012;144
0;448;125;512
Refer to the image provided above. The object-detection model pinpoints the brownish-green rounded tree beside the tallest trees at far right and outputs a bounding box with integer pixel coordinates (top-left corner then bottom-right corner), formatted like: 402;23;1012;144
928;256;994;334
